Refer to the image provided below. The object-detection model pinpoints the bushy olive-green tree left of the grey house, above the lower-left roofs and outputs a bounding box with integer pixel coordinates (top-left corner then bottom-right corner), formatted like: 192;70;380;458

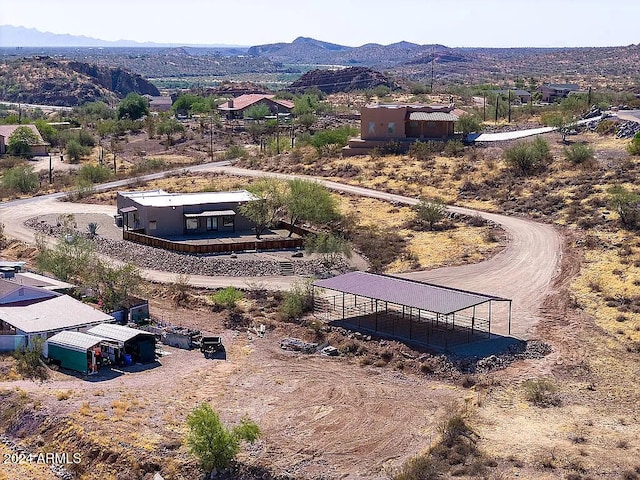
36;234;95;282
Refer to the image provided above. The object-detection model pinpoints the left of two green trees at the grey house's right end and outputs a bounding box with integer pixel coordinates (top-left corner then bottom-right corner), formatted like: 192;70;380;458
240;178;284;239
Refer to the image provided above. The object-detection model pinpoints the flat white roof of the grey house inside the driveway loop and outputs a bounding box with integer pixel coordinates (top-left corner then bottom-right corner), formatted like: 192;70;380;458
118;190;257;207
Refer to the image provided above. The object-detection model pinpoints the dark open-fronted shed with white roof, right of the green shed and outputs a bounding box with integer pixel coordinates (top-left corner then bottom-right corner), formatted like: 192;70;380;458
87;323;156;363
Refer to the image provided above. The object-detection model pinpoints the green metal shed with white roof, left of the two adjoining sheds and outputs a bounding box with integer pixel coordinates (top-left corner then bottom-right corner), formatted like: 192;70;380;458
44;331;104;375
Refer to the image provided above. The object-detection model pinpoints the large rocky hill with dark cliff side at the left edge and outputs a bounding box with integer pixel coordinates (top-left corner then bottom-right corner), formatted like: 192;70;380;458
0;57;160;107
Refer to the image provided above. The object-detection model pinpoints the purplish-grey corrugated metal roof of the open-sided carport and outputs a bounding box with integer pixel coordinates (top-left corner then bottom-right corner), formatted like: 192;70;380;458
313;272;509;315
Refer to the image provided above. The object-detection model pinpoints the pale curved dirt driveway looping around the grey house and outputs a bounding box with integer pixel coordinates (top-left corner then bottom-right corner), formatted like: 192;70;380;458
0;163;562;338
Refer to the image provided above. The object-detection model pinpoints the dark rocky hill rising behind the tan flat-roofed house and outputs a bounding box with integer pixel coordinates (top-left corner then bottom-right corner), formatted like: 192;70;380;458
288;67;399;93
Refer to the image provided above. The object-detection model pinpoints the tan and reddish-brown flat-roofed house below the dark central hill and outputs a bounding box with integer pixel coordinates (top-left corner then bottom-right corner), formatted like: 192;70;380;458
342;104;465;155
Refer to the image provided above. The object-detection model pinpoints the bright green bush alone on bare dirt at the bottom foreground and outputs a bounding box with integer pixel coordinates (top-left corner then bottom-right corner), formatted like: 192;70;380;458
187;403;260;472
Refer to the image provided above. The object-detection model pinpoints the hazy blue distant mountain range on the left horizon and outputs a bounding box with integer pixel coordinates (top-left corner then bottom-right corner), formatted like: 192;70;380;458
0;25;247;50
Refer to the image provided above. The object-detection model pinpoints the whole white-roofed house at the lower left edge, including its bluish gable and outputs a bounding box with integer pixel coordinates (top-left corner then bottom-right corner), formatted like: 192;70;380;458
0;280;114;345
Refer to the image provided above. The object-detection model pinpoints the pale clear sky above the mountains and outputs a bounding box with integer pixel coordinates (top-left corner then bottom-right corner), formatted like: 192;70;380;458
0;0;640;47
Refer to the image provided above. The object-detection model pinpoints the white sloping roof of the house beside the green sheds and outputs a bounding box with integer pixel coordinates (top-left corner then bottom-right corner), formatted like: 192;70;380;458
0;295;114;334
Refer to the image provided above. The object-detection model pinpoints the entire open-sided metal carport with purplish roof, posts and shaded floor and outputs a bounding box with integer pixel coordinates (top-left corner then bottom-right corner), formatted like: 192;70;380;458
313;272;511;349
